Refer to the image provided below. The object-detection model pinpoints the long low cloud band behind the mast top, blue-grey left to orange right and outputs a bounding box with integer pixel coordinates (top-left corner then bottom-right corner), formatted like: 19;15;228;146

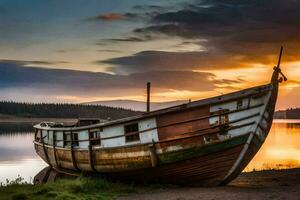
0;63;242;100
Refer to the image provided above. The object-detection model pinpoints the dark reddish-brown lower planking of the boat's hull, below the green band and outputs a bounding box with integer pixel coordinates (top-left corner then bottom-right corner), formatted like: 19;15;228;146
104;146;243;185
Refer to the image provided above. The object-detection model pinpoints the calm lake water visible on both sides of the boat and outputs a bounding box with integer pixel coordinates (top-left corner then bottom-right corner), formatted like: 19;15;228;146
0;120;300;182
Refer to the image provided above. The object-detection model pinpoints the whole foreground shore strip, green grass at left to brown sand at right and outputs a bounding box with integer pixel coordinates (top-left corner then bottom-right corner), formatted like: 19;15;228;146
0;168;300;200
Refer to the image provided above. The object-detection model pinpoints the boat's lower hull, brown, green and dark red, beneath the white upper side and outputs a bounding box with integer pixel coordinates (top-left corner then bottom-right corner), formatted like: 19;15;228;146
35;134;250;185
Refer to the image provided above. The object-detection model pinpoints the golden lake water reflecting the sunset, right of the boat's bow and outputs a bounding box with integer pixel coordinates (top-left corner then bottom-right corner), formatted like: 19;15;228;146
245;120;300;171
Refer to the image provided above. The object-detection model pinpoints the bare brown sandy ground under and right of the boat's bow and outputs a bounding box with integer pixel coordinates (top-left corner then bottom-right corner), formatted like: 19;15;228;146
120;169;300;200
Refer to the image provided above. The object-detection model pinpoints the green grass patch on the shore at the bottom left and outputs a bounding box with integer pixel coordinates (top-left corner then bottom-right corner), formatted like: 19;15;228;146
0;176;157;200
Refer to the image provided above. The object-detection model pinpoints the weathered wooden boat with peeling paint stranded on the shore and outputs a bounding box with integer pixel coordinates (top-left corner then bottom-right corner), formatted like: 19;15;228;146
34;49;286;185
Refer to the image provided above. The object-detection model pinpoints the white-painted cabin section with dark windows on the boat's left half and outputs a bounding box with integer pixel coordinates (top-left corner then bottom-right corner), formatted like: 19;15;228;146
35;118;158;149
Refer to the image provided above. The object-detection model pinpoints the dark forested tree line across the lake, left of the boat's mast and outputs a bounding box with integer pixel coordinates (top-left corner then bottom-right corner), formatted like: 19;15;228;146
0;101;141;120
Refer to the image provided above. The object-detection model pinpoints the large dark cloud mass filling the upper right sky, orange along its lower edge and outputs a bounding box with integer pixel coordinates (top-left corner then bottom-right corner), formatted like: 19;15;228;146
99;0;300;73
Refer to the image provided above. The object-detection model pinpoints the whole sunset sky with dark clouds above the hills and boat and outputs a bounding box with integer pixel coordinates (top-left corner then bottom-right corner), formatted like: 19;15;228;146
0;0;300;110
